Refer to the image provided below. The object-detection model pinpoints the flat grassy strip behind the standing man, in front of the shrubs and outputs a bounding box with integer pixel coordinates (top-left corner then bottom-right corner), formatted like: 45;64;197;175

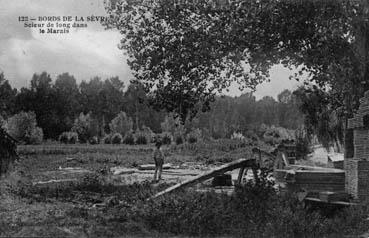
18;140;256;176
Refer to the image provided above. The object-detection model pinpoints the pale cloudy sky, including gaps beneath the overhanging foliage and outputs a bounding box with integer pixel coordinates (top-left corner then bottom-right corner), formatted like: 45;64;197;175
0;0;297;98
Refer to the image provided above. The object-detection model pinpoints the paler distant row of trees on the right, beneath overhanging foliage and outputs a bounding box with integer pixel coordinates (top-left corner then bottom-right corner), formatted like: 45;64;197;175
185;90;304;138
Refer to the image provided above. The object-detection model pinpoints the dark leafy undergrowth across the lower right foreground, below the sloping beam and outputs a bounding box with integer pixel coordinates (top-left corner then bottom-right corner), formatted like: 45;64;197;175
127;172;368;238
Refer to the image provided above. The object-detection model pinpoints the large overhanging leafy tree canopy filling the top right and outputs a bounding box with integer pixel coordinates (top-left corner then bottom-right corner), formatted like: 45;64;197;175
103;0;369;152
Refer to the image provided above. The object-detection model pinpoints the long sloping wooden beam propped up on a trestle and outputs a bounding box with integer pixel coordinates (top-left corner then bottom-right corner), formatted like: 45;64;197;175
149;159;255;200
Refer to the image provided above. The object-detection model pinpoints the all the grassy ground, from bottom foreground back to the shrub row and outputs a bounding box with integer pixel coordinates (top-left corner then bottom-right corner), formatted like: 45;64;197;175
0;141;369;237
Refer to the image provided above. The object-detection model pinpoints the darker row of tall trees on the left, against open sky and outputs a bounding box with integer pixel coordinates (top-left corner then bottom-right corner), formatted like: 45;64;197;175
0;72;164;139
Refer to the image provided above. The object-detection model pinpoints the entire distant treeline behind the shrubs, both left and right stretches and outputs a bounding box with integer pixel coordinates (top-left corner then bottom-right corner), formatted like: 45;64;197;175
0;72;303;139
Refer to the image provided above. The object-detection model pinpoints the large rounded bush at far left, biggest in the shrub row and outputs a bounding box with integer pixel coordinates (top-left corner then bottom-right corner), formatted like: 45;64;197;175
6;112;43;144
